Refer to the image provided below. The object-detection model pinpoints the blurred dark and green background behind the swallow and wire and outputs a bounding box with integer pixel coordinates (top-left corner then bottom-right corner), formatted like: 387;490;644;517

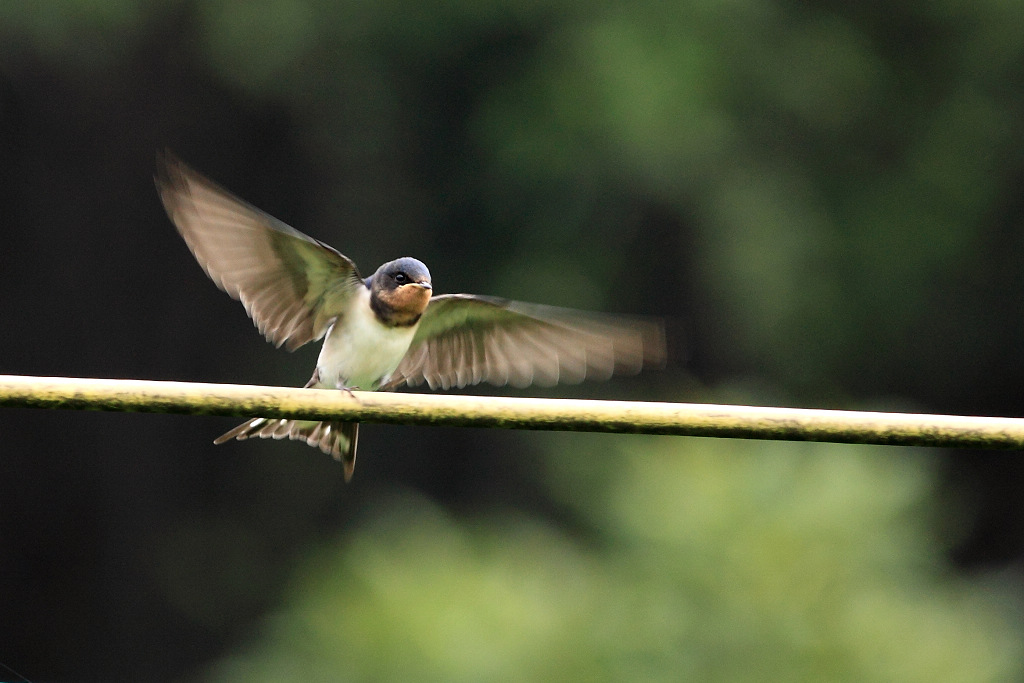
0;0;1024;683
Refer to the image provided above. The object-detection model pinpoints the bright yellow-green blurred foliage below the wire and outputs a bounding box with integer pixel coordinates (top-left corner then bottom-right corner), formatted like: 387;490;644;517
203;436;1024;683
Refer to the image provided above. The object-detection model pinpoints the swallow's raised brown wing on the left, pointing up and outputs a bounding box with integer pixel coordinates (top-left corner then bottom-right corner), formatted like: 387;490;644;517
157;153;366;351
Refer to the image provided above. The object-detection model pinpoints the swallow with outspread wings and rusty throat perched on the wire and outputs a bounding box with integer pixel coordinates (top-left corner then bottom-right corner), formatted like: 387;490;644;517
156;152;666;481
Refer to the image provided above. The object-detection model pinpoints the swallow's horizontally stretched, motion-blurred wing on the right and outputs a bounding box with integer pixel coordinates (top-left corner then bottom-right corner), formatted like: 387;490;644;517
385;294;666;389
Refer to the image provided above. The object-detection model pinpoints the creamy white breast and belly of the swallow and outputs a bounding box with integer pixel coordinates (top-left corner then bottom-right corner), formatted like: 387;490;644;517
316;289;416;391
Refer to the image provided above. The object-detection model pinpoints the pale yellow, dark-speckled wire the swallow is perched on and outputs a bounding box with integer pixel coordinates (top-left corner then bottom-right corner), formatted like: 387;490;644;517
0;375;1024;449
